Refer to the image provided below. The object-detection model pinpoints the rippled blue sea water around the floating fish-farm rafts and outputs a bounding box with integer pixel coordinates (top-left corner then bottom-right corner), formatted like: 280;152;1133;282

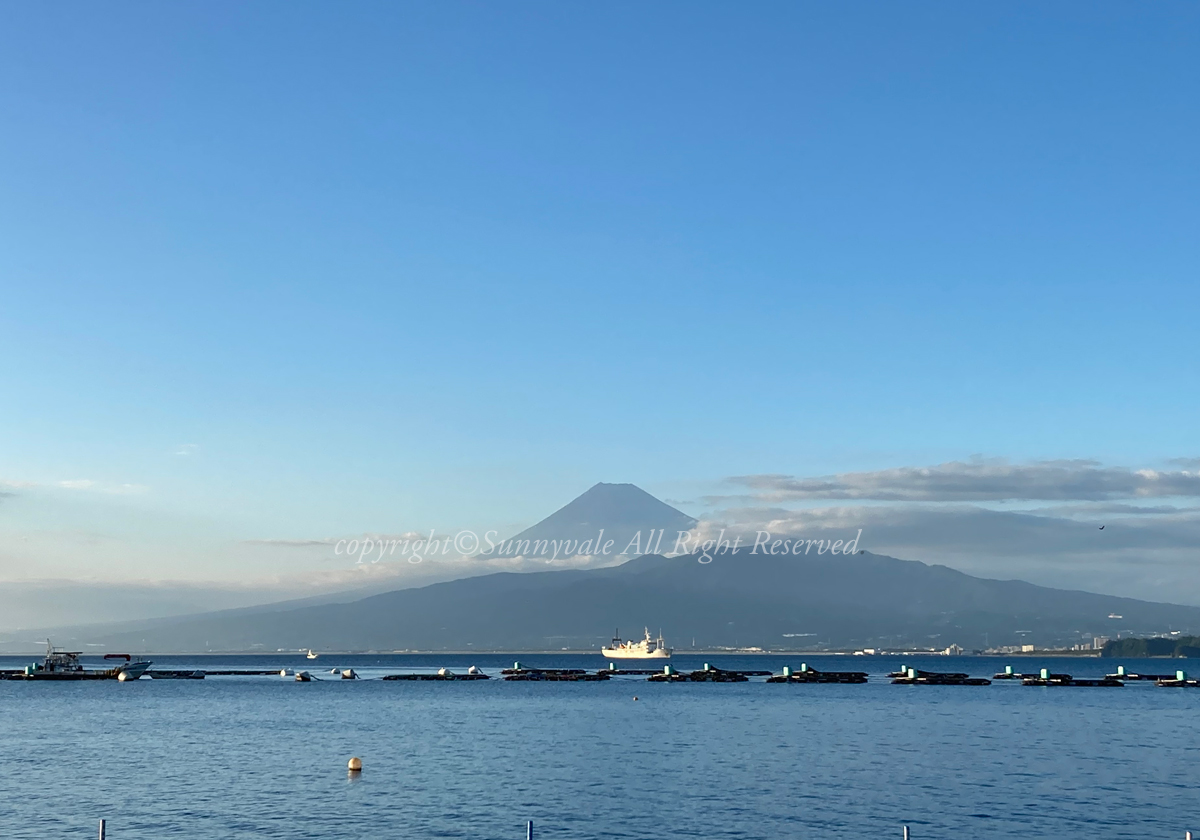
0;654;1200;840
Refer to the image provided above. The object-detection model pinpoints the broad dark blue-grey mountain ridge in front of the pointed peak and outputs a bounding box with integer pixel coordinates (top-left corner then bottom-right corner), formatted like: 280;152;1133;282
72;551;1200;650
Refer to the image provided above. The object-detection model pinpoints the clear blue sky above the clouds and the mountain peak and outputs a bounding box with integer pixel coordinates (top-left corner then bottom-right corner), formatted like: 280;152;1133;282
0;2;1200;607
